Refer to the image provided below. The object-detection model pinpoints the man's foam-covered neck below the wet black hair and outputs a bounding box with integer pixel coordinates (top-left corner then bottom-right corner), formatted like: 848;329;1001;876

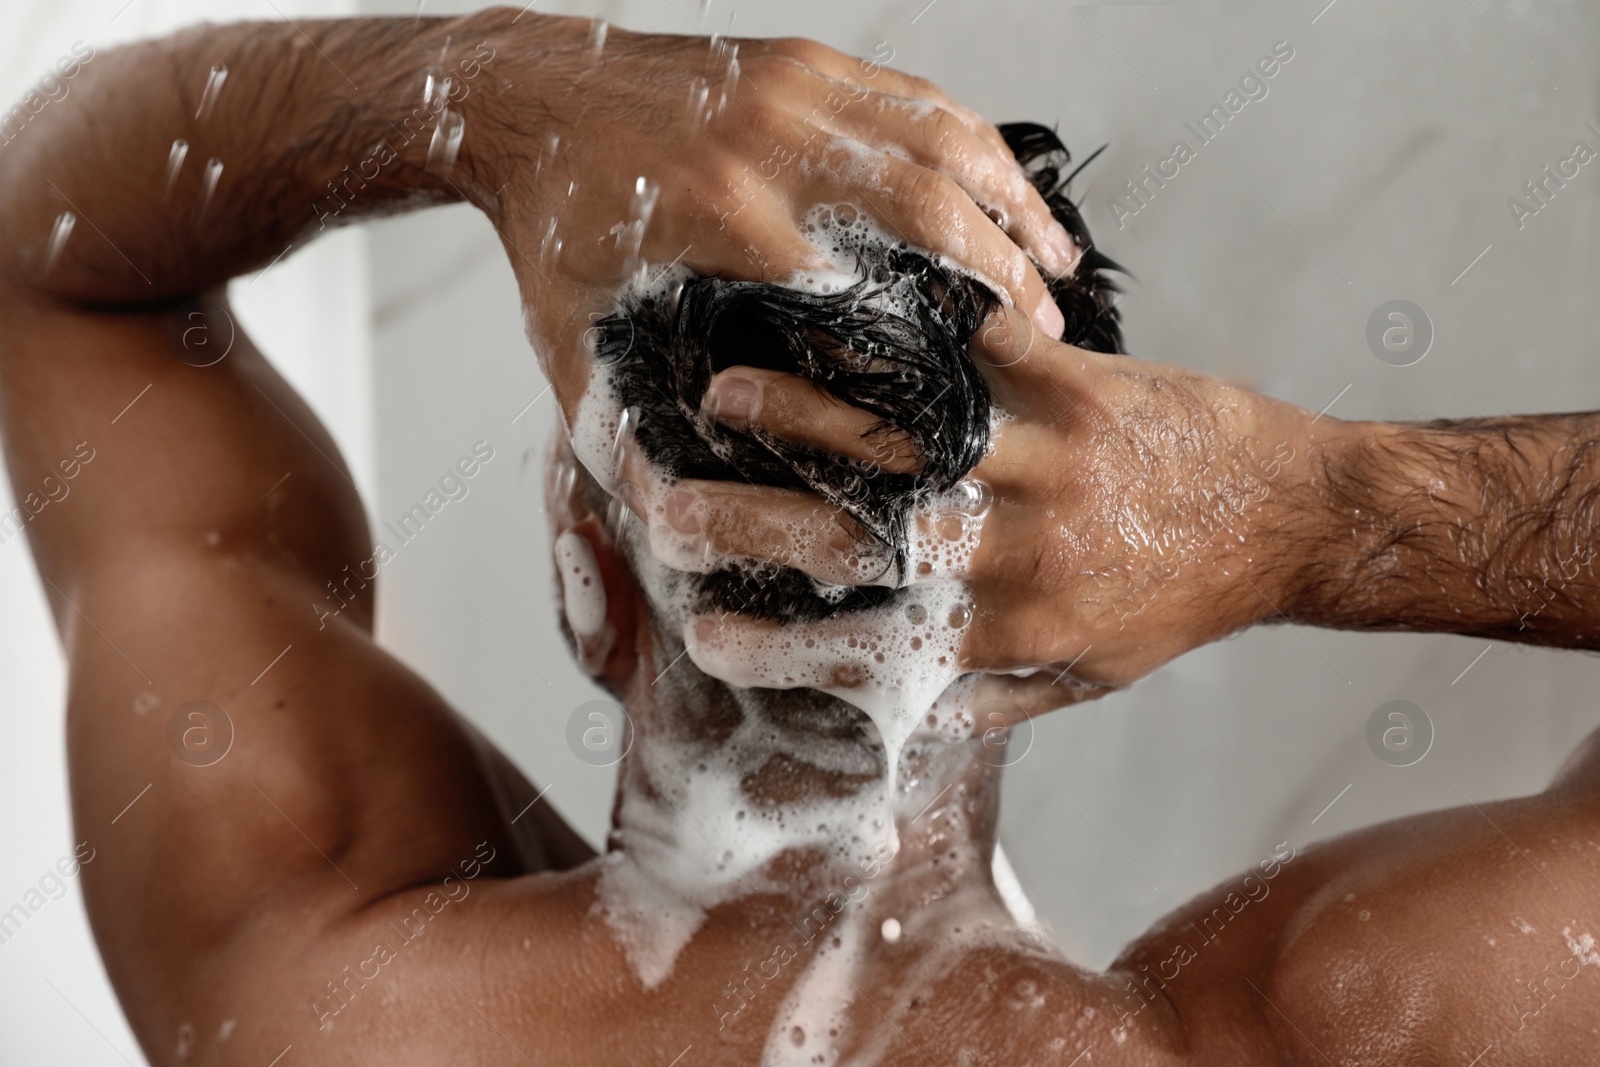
600;675;1008;987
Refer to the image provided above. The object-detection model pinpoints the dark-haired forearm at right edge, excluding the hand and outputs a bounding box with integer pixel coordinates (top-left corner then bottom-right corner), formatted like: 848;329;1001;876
1282;414;1600;649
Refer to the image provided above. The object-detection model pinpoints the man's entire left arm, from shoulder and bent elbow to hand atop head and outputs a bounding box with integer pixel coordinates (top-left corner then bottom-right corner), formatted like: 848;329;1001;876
0;10;1075;1059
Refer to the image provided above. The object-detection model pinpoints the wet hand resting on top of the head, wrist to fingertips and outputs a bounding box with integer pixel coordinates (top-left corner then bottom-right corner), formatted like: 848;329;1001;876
466;16;1078;413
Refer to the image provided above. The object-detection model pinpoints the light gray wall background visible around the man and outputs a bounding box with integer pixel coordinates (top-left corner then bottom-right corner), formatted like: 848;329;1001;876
0;0;1600;1064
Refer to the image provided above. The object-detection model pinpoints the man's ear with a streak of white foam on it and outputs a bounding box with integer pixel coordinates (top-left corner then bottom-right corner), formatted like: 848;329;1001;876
555;515;643;693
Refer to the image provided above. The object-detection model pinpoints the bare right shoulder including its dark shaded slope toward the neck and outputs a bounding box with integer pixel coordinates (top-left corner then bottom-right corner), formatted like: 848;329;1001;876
1112;737;1600;1067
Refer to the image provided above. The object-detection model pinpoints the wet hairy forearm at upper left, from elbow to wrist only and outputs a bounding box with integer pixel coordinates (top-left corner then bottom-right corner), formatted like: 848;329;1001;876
0;19;494;306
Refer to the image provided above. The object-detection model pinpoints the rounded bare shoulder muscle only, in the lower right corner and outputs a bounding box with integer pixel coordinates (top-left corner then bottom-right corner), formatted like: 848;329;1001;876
1261;741;1600;1065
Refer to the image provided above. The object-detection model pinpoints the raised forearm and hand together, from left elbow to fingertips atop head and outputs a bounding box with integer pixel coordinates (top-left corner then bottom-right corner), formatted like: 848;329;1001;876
0;8;1078;428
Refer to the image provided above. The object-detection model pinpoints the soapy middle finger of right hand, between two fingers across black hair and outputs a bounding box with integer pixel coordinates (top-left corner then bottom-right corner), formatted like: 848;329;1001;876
651;480;896;585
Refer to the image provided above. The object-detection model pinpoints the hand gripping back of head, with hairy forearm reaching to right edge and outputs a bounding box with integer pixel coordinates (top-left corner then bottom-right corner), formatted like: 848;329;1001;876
636;312;1600;709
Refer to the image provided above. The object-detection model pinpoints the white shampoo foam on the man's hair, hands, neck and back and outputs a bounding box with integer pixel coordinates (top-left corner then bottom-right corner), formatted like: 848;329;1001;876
557;208;1000;1067
